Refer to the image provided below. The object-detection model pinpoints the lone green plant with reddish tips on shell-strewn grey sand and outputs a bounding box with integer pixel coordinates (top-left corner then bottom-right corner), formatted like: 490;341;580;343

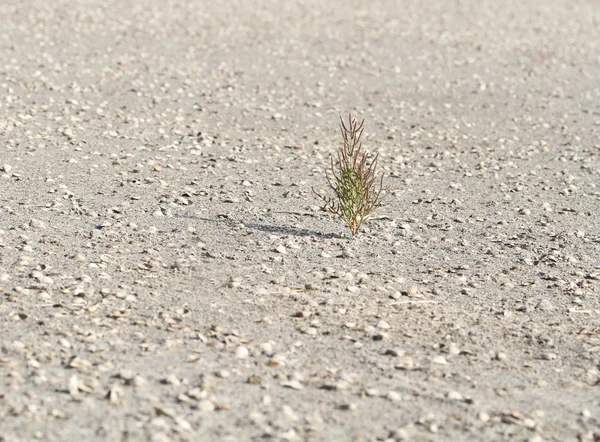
313;115;383;236
